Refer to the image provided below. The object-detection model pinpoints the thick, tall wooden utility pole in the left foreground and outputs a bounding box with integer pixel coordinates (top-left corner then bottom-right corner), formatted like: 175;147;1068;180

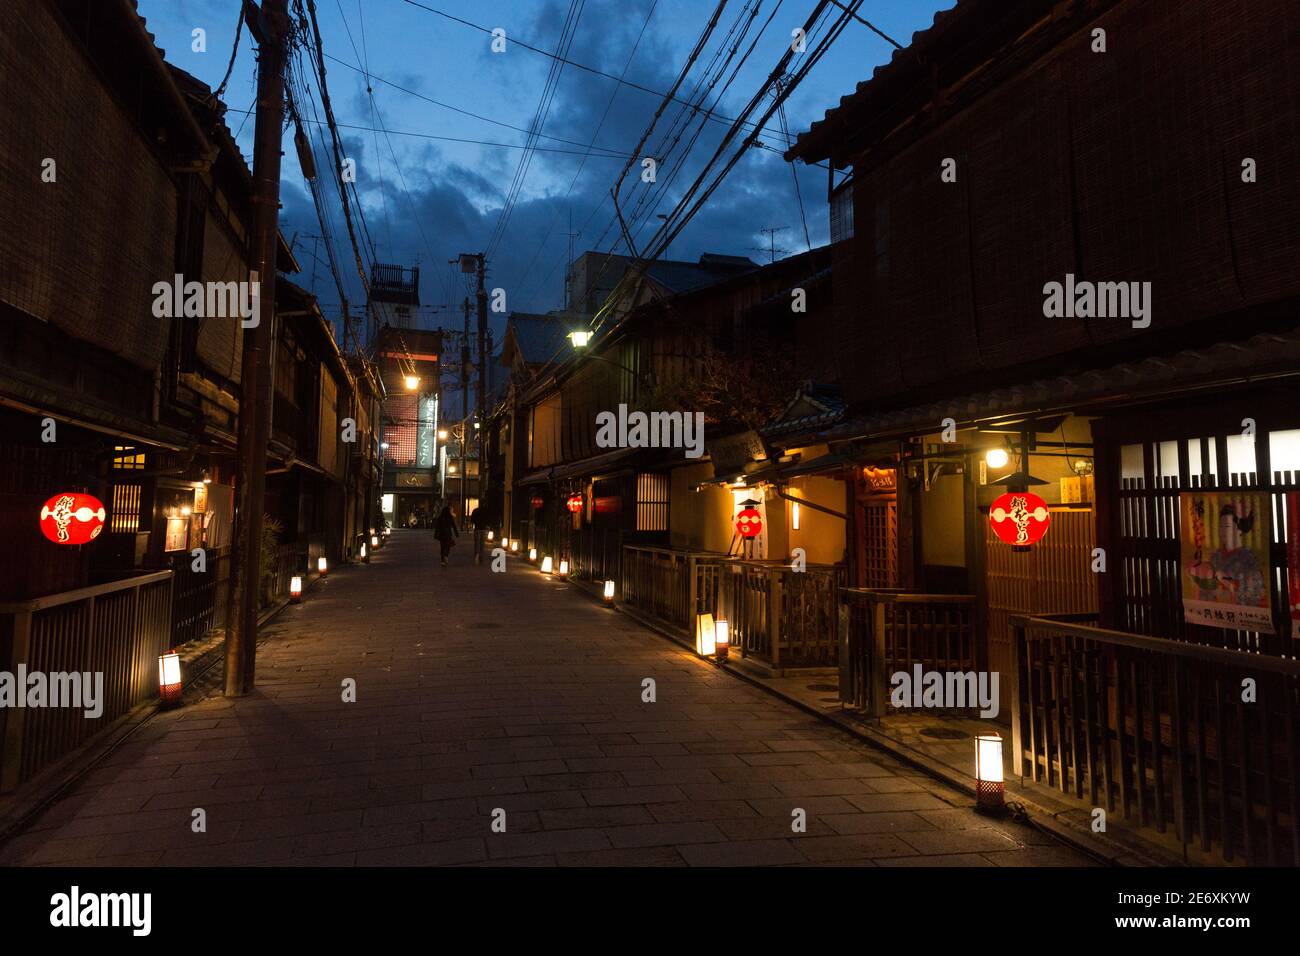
226;0;291;697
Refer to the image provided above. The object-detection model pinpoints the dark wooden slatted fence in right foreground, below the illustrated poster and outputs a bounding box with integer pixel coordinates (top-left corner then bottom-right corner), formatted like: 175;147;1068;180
1011;615;1300;865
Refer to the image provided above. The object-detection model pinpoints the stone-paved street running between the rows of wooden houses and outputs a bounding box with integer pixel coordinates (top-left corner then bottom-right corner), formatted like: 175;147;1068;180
0;532;1088;866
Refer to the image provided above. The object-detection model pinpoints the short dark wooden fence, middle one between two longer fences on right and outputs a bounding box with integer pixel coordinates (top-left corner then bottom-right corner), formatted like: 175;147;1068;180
840;588;975;717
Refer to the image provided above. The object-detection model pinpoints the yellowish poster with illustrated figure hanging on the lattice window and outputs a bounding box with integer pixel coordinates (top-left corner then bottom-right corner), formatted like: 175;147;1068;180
1179;492;1274;633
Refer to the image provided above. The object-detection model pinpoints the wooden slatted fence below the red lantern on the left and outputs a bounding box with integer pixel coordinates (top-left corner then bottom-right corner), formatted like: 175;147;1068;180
0;571;173;791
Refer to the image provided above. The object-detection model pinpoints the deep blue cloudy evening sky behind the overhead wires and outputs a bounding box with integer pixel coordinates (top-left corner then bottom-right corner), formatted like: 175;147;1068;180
139;0;952;335
